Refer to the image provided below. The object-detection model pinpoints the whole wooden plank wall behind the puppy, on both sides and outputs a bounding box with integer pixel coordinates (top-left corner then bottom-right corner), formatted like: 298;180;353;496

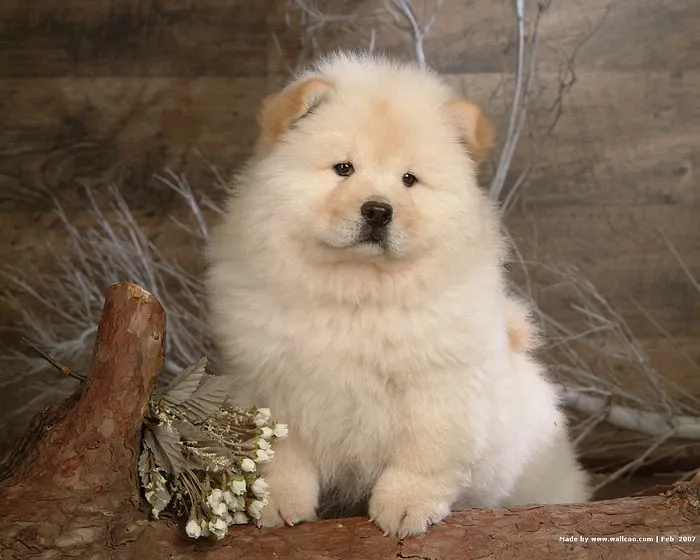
0;0;700;468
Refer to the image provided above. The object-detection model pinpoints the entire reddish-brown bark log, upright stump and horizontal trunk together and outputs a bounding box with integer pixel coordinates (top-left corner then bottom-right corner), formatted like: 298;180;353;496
0;283;700;560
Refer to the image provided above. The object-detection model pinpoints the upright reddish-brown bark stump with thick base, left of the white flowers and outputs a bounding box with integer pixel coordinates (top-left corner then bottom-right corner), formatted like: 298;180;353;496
0;283;165;560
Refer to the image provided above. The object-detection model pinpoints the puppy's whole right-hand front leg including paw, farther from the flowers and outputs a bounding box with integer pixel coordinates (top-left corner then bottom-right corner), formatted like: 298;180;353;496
369;394;470;538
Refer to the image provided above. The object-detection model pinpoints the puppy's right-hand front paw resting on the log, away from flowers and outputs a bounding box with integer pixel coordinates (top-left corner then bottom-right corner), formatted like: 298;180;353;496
369;471;450;539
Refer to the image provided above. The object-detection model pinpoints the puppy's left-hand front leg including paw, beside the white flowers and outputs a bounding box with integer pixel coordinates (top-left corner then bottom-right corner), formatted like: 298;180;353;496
258;432;319;527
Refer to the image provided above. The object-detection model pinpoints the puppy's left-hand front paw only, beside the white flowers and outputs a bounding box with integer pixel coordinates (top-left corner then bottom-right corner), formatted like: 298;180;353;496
257;474;318;527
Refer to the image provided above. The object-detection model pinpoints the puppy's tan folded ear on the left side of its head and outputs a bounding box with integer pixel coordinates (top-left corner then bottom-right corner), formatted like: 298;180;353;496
258;78;331;150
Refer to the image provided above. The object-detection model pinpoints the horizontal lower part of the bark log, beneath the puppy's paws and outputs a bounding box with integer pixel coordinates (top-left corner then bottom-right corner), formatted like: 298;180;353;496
0;494;700;560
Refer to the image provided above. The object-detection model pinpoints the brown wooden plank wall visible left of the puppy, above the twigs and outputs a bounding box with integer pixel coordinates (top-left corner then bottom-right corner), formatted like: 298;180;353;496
0;0;294;442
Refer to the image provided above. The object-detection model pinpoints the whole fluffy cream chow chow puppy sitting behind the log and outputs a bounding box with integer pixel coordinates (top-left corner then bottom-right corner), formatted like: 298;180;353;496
207;53;589;537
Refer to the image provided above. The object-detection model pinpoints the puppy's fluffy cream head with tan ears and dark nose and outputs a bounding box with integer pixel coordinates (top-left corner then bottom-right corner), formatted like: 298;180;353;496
241;55;493;263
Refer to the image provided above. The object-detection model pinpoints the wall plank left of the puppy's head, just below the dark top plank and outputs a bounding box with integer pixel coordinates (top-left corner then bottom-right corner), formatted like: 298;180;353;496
0;75;267;210
